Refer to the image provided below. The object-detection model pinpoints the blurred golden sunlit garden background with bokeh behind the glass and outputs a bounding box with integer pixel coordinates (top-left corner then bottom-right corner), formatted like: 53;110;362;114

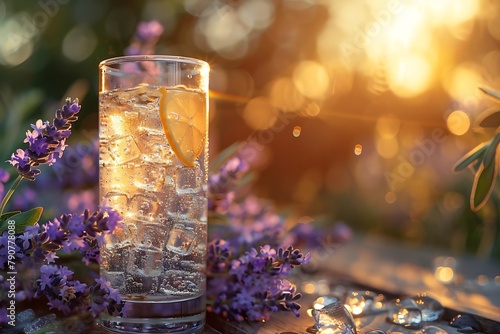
0;0;500;259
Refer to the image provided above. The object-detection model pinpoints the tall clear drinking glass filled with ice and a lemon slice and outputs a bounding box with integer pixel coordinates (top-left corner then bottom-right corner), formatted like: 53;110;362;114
99;56;209;333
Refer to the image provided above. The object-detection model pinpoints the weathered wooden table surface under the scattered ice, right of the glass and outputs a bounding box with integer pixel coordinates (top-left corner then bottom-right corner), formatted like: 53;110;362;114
207;236;500;334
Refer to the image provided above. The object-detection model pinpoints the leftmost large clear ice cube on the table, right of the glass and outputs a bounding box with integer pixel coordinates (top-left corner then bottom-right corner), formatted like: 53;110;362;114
312;301;356;334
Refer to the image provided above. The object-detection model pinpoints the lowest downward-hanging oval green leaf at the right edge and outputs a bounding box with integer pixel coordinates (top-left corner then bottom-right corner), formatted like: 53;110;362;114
470;155;498;211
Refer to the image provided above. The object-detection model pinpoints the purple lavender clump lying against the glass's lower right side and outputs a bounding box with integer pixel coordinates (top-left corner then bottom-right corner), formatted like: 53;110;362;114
207;239;311;321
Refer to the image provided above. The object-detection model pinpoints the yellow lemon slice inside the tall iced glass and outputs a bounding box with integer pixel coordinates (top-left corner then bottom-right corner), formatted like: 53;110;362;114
160;87;207;166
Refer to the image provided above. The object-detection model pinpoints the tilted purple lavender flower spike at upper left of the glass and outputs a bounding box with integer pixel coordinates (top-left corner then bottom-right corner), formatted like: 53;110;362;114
7;98;81;181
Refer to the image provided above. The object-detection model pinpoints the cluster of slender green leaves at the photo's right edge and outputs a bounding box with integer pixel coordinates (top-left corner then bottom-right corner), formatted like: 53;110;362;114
454;88;500;211
